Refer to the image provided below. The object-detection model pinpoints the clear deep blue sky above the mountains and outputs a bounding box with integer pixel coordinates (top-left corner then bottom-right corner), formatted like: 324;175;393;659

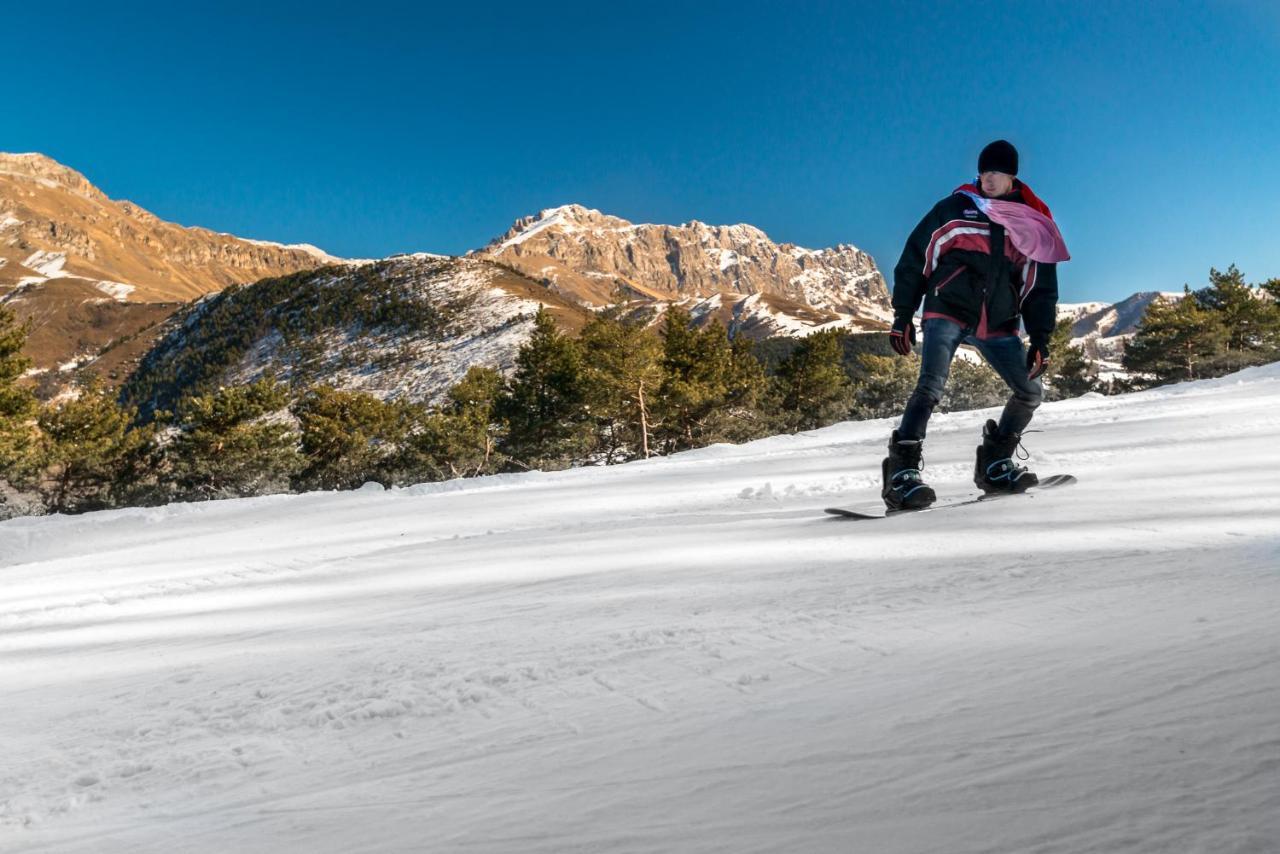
0;0;1280;302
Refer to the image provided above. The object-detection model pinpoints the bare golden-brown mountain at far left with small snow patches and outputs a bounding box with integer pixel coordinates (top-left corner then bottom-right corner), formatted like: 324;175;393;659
0;154;339;397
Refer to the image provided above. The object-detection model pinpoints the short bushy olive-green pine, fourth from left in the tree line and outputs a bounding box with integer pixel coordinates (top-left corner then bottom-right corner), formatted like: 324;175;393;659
292;385;404;489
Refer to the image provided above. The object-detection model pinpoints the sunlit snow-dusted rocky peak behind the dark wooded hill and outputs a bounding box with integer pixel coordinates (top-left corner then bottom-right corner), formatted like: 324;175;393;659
477;205;892;337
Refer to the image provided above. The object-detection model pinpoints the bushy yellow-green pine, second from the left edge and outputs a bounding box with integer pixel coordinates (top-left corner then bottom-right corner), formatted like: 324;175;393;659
37;376;155;513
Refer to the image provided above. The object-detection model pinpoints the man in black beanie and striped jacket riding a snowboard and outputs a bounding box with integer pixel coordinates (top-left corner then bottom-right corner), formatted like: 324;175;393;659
881;140;1070;510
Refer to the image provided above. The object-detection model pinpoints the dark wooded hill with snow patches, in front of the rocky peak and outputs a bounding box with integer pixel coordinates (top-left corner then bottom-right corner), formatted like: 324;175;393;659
124;254;589;412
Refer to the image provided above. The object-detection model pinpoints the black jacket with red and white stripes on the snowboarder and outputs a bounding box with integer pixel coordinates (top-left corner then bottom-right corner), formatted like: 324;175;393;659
893;181;1057;342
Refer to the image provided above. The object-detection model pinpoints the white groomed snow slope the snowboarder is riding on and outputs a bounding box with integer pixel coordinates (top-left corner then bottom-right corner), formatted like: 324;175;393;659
0;365;1280;854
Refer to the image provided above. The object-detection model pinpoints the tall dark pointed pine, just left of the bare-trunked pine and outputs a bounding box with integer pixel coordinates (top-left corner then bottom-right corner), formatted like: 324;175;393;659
497;309;591;469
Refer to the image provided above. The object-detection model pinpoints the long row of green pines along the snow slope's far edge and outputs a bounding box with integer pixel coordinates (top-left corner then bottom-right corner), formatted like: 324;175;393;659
0;268;1249;522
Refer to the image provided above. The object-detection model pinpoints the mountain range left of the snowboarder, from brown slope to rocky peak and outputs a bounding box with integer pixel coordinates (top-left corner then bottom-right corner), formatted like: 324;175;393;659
0;154;891;407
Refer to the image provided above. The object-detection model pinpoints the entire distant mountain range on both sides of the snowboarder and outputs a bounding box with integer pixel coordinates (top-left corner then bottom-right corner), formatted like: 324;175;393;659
0;154;1172;405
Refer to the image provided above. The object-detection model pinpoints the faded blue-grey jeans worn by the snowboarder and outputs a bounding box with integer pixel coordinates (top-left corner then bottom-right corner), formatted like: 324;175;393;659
897;318;1044;439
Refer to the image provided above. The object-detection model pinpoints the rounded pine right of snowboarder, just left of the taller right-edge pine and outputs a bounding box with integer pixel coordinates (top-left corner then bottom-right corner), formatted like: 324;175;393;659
1123;288;1228;384
